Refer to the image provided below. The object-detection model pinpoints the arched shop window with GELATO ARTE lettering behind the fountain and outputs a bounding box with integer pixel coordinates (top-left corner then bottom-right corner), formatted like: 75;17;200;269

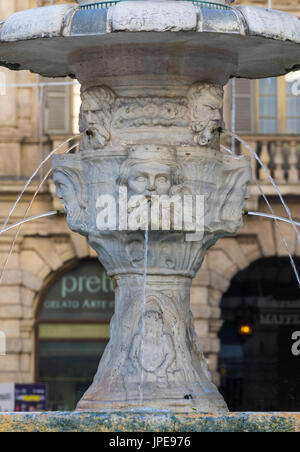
36;259;114;411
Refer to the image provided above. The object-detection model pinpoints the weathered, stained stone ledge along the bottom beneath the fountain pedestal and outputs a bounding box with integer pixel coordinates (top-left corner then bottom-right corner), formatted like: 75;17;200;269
0;410;300;432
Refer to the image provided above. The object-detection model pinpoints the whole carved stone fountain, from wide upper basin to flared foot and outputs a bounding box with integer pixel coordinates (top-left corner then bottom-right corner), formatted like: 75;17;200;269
0;0;300;413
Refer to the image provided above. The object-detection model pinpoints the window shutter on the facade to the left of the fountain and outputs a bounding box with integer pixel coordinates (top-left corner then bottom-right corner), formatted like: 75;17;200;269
44;78;71;135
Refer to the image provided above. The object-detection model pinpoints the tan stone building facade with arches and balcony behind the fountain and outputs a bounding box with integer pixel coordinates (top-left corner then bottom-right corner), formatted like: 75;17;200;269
0;0;300;411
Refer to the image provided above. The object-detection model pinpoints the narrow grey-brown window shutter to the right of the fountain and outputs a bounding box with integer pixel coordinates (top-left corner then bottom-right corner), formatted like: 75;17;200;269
236;78;254;134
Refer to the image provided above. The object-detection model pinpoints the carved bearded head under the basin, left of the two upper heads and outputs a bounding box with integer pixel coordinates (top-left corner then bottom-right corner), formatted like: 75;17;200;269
79;86;116;150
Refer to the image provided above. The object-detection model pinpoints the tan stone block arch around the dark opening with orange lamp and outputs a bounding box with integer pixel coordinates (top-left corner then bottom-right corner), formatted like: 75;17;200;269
191;215;300;386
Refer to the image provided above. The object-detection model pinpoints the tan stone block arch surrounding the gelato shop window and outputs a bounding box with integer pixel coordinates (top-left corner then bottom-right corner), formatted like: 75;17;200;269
0;231;95;383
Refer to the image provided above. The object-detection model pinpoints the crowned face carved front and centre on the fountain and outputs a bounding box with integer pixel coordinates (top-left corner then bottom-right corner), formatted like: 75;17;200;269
128;162;171;196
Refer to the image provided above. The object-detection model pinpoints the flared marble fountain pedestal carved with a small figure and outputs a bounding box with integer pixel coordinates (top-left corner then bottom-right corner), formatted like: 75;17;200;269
78;275;226;412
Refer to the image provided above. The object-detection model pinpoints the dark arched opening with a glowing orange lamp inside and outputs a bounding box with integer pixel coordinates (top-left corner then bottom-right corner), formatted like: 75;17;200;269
219;257;300;411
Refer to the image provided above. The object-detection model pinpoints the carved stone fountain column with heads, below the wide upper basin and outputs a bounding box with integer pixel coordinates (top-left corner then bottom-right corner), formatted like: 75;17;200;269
53;46;251;412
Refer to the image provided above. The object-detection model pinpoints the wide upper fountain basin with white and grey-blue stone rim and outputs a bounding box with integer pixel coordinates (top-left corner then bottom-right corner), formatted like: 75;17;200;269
0;1;300;78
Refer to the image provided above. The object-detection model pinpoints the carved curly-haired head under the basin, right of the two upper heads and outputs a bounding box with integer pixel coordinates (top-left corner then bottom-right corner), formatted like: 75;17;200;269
188;83;224;147
